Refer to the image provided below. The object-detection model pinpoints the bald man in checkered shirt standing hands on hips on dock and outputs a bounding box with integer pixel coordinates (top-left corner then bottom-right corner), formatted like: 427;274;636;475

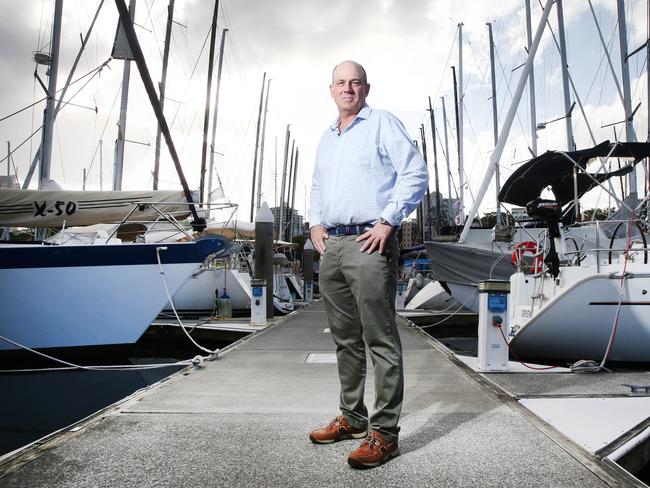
309;61;428;468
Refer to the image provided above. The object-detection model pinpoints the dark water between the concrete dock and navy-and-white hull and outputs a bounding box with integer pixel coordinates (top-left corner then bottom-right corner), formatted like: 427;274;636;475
0;339;238;456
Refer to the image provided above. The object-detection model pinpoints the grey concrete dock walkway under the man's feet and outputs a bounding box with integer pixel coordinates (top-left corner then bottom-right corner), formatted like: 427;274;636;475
0;303;632;488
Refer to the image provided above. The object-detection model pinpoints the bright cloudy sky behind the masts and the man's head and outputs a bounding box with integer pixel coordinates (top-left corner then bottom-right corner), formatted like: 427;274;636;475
0;0;648;223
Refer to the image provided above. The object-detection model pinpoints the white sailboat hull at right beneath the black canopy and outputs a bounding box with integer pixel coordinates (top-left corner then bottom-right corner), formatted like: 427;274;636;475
509;263;650;362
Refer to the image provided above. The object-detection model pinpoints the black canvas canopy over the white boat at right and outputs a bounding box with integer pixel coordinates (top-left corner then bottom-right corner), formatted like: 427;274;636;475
499;141;650;207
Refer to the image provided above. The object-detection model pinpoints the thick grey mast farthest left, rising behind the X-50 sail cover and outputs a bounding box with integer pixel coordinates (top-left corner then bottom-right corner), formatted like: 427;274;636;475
38;0;63;189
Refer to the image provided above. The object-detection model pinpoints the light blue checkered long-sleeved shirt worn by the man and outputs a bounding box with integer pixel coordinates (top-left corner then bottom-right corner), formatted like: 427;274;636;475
309;105;429;227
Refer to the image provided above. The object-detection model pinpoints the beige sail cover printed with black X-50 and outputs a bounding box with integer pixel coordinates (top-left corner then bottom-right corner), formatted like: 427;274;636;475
0;188;190;227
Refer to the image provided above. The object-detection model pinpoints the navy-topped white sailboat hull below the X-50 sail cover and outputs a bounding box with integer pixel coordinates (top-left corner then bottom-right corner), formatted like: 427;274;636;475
0;239;223;351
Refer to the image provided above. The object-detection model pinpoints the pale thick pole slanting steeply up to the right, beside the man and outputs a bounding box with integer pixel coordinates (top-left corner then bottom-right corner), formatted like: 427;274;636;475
458;0;553;242
